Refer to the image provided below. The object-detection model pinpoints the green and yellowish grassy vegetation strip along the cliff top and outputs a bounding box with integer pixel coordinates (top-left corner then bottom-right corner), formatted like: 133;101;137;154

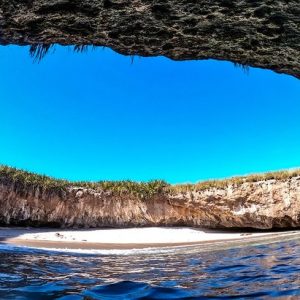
0;165;300;198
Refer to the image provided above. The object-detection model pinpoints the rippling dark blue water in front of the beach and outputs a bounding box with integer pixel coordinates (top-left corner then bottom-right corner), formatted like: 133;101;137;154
0;238;300;300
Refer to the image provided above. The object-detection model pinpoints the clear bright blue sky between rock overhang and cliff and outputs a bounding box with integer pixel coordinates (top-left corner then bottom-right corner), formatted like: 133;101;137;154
0;47;300;183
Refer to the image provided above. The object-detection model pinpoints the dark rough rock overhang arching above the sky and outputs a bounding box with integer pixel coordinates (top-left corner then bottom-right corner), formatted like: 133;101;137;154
0;0;300;78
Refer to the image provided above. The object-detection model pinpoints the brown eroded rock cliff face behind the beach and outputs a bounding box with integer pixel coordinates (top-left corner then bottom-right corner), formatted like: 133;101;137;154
0;177;300;229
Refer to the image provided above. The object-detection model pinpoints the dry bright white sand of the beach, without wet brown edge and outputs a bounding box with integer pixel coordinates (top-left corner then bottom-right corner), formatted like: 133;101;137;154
0;227;286;244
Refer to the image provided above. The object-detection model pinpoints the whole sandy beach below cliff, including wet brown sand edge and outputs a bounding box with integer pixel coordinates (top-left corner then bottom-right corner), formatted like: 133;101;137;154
0;227;293;250
